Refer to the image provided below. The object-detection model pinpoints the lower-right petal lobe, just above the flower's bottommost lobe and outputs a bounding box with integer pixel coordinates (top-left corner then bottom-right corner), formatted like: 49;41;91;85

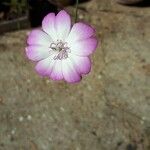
69;55;91;74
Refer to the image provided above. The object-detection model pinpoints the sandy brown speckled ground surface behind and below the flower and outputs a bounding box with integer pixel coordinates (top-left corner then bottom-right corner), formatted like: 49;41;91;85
0;0;150;150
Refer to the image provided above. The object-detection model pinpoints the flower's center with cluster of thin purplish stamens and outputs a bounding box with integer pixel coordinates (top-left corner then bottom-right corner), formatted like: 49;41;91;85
50;40;70;60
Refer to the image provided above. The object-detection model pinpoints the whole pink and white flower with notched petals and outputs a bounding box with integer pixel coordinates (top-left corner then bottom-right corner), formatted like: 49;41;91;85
26;10;98;83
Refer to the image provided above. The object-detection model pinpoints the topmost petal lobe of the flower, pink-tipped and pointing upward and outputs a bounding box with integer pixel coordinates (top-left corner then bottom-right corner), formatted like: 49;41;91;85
56;10;71;41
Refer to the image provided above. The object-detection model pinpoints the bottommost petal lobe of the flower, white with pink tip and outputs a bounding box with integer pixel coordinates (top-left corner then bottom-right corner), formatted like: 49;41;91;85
62;58;81;83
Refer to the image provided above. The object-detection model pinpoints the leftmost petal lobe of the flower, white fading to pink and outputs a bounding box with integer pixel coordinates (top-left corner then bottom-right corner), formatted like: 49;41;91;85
26;45;50;61
